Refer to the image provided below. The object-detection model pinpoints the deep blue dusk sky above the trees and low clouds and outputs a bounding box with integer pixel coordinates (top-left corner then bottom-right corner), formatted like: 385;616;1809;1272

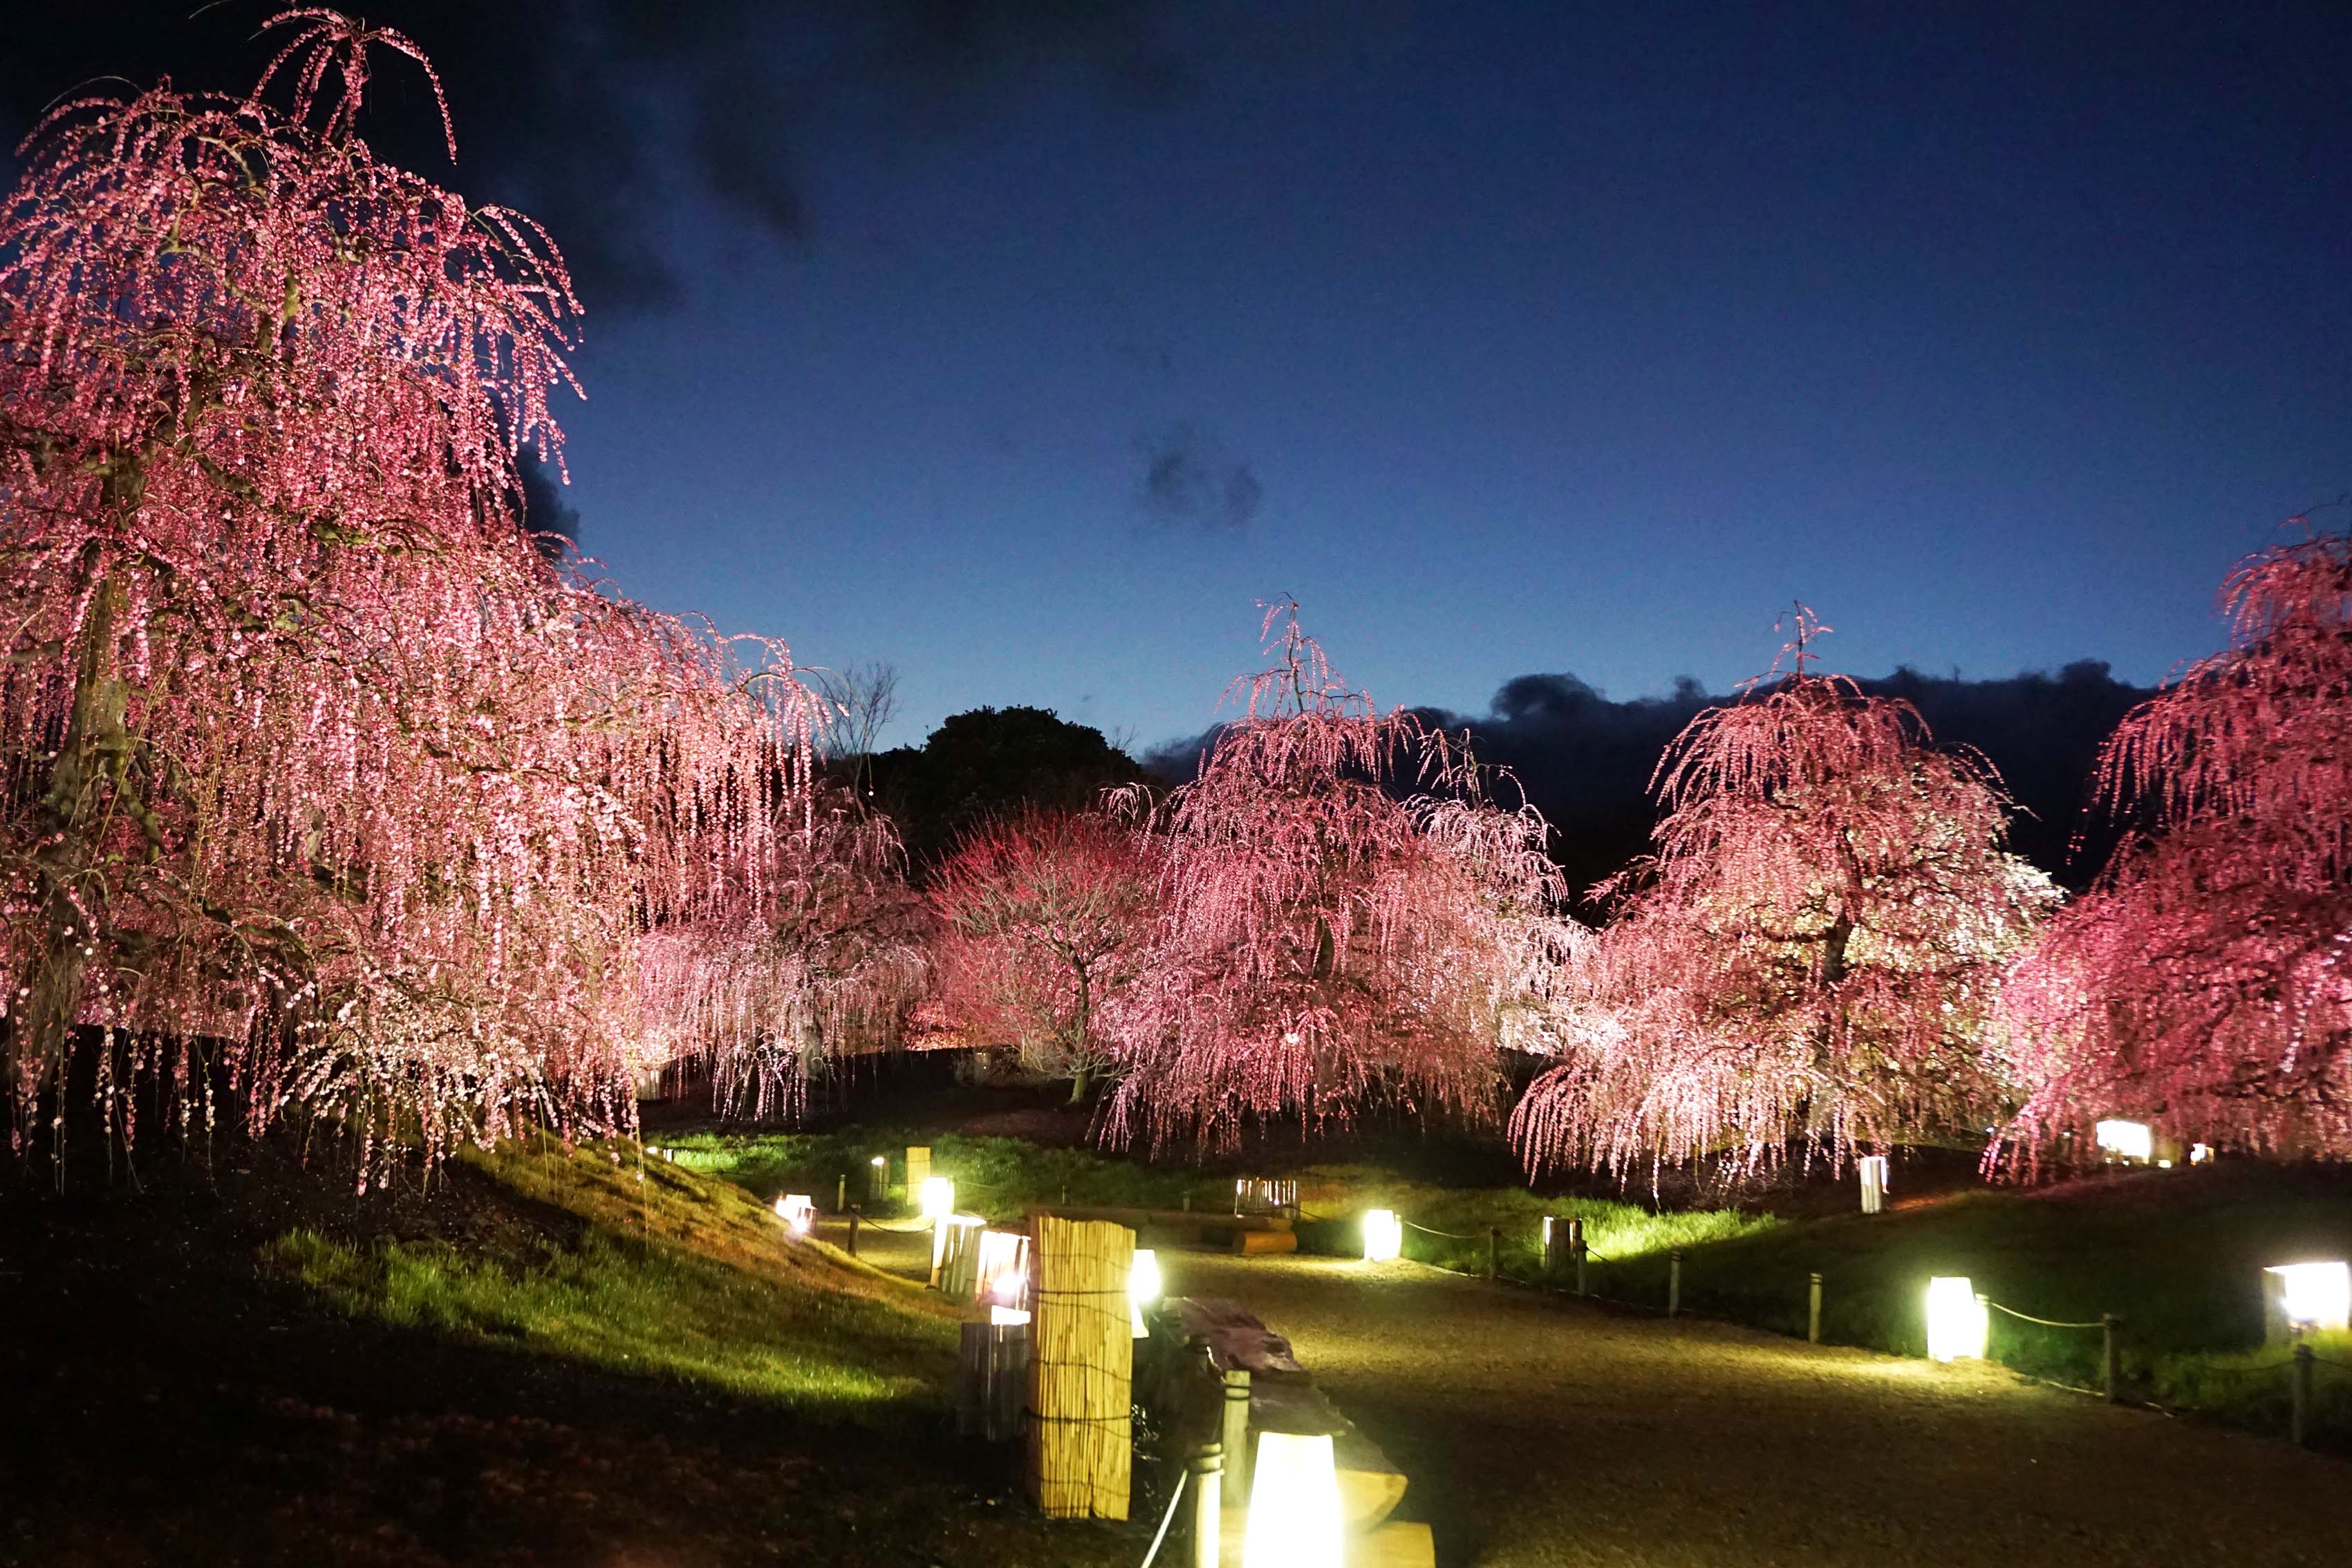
0;0;2352;747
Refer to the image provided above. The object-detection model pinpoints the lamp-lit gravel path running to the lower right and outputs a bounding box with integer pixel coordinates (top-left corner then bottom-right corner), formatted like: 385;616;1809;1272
1159;1251;2352;1568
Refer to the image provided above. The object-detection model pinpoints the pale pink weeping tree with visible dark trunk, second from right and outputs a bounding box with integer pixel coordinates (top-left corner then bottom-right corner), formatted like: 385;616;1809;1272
1512;606;2055;1175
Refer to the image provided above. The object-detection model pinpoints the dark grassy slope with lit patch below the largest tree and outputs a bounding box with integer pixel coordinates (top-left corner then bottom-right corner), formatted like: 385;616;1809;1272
0;1152;1136;1566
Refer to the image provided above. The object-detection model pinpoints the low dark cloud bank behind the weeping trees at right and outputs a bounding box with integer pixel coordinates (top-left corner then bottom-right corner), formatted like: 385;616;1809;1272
1146;660;2149;891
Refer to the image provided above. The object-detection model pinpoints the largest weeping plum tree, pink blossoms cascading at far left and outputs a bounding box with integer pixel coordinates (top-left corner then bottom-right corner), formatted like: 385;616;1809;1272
0;10;812;1180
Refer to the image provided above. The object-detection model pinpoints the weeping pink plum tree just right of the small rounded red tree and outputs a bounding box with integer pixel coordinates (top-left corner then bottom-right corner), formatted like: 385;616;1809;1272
1108;601;1578;1145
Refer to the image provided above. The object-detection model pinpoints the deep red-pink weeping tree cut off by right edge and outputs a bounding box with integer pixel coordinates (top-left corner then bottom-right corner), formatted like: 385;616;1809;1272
1988;536;2352;1168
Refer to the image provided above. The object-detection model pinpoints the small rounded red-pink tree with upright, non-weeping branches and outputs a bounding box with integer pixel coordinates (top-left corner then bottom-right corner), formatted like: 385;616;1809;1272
926;811;1159;1103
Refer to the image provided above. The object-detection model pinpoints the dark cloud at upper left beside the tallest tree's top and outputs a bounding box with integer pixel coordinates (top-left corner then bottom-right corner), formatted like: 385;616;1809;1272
0;0;1188;310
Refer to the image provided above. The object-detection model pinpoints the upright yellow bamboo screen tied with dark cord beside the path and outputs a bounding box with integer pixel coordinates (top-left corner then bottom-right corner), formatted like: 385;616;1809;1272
1025;1215;1136;1519
